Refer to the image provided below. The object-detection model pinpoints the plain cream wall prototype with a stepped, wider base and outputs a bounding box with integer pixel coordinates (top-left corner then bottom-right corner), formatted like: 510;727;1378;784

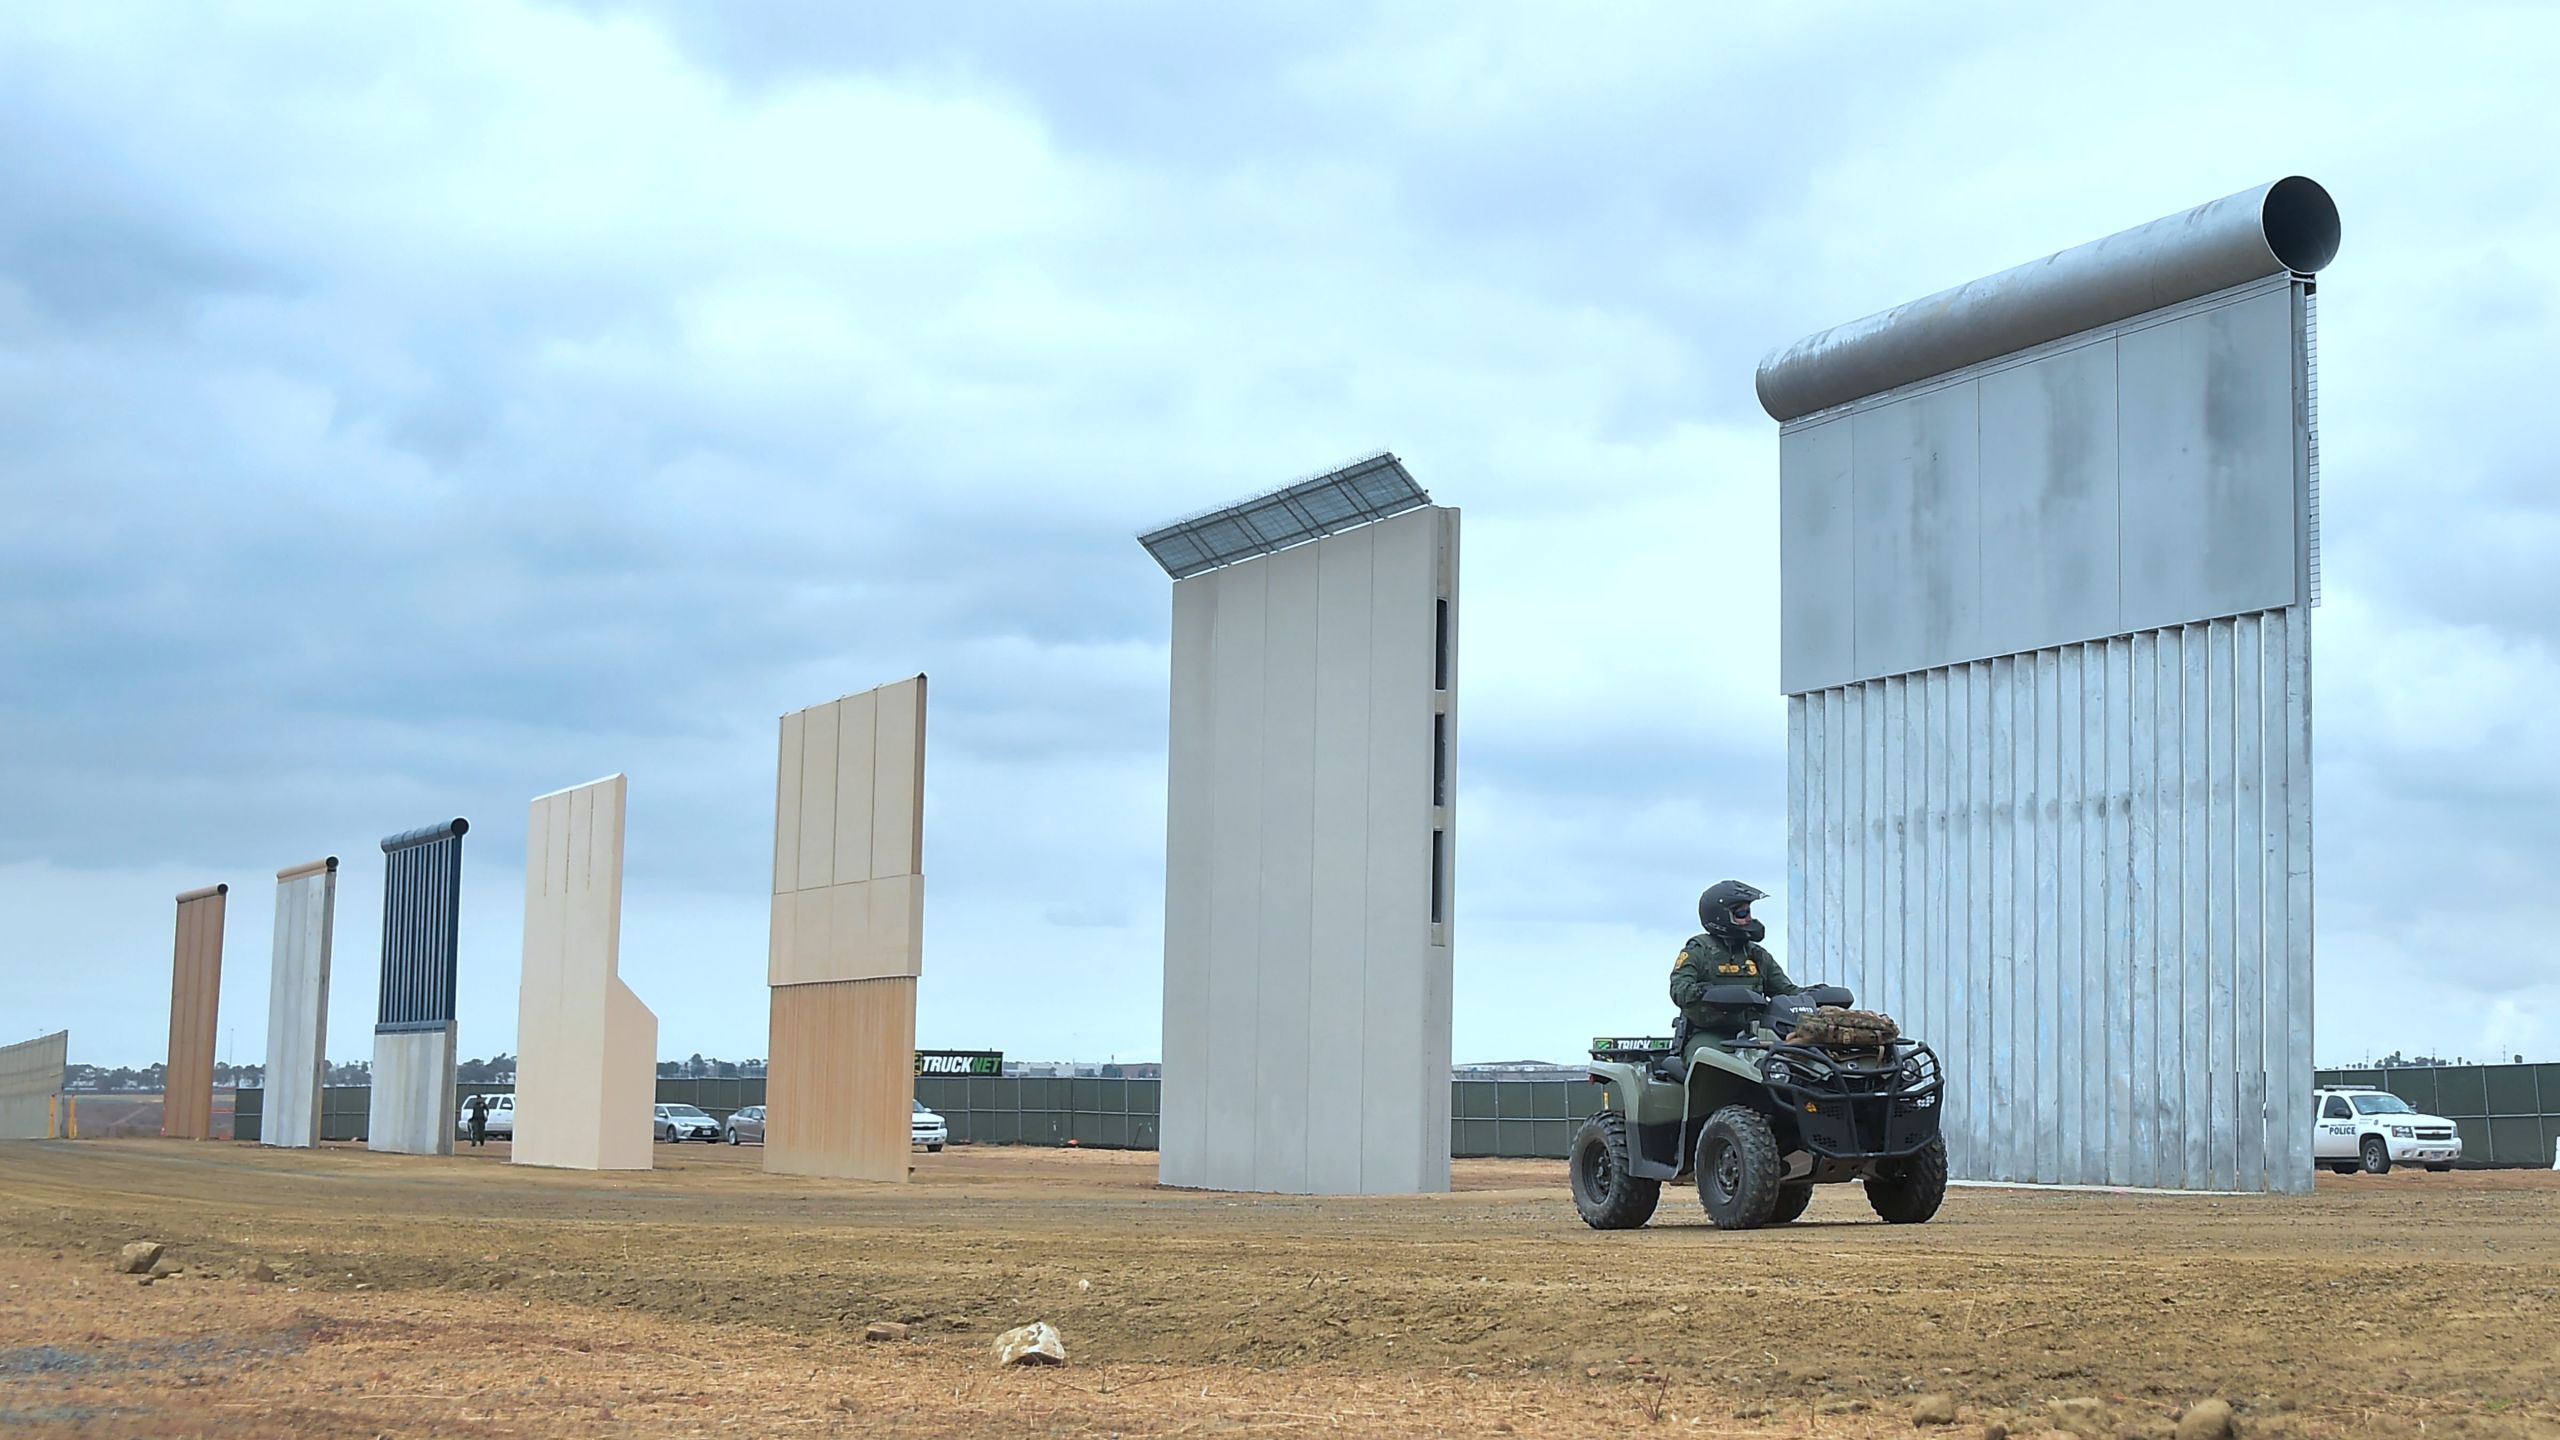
512;776;658;1171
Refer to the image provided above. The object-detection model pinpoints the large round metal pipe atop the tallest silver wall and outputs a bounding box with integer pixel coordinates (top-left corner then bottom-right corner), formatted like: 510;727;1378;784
1754;174;2337;423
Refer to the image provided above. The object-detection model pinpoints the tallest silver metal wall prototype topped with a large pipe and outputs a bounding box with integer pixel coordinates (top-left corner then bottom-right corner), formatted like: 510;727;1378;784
1759;177;2337;1191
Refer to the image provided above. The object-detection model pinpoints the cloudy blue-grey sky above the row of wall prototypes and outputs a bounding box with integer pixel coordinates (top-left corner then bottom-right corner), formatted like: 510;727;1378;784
0;0;2560;1063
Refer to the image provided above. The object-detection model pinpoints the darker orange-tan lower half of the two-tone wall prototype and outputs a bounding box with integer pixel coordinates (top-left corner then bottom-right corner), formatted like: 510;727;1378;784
765;979;916;1181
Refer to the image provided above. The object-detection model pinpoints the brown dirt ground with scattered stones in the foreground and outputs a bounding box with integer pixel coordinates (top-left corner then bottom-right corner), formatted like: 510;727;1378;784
0;1140;2560;1440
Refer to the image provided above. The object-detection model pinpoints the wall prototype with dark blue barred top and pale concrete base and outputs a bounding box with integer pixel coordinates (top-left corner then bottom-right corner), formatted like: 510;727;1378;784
366;817;471;1156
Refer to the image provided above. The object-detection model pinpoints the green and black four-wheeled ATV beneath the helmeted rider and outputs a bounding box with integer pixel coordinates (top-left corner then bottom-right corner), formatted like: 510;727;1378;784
1572;984;1946;1230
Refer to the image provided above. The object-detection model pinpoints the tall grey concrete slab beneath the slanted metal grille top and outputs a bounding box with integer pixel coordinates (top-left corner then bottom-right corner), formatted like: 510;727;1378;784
1157;481;1459;1194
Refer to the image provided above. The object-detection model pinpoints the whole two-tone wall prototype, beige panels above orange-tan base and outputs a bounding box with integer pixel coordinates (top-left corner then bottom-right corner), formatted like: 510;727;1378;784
765;674;924;1181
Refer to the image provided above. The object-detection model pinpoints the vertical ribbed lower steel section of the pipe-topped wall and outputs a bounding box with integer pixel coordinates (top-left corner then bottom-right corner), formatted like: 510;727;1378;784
1787;607;2312;1191
